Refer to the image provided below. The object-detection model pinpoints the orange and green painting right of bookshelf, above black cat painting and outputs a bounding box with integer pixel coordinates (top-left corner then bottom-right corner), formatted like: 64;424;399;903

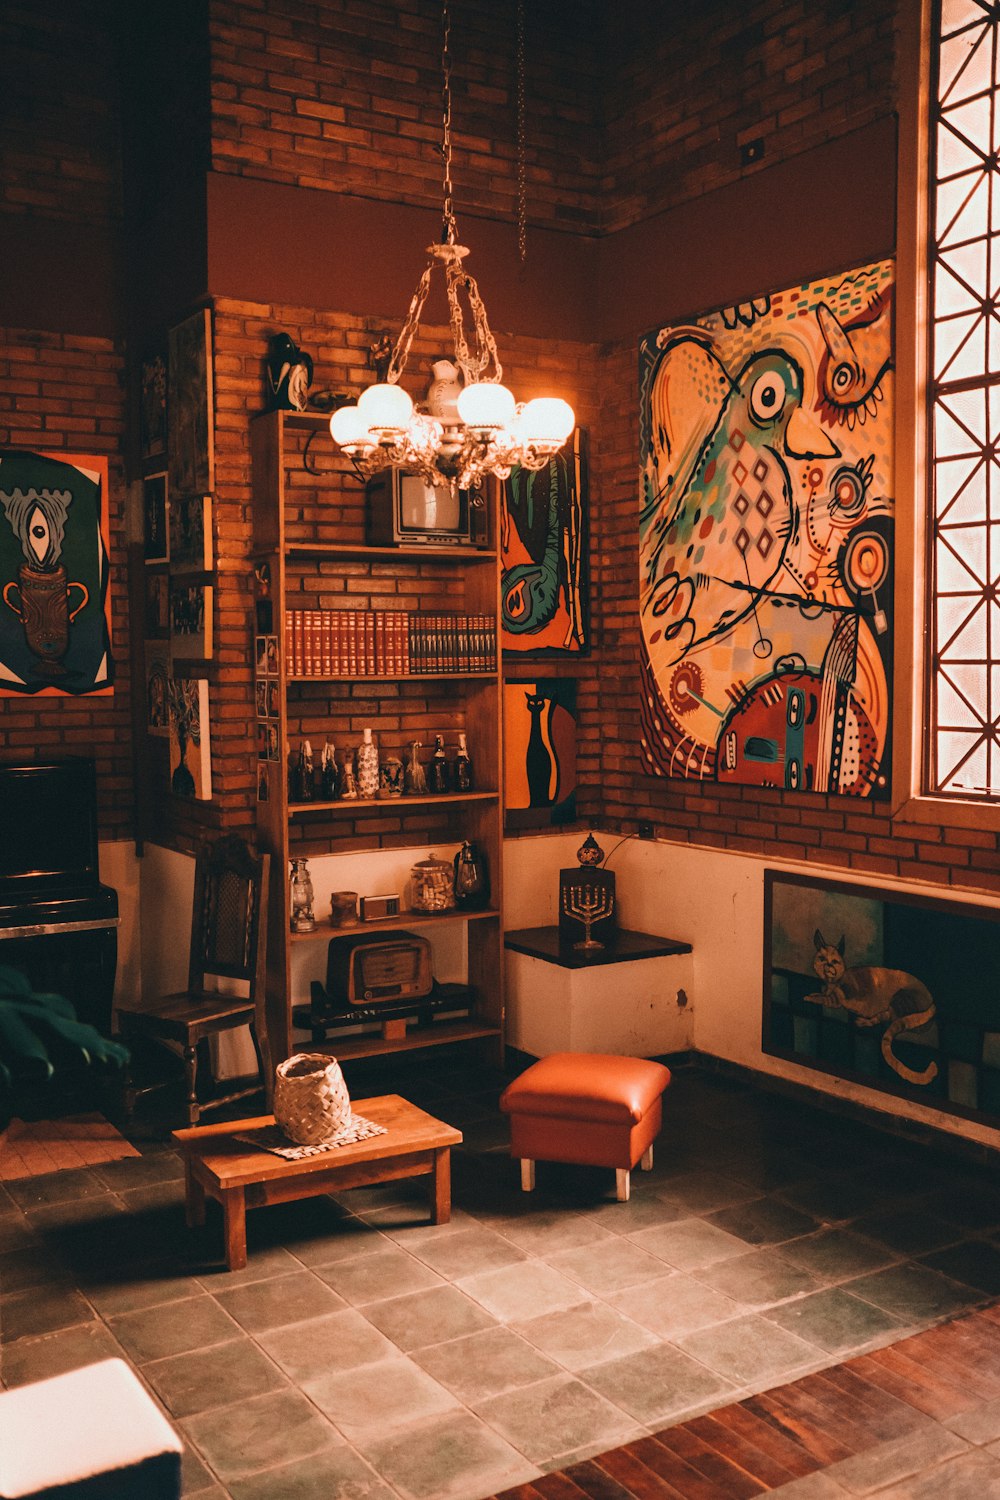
499;428;591;656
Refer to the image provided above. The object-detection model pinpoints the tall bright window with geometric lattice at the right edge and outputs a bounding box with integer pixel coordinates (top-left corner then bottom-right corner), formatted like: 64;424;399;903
930;0;1000;800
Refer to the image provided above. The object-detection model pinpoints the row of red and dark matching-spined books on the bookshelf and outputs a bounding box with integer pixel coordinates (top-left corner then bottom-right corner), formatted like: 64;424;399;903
285;609;496;677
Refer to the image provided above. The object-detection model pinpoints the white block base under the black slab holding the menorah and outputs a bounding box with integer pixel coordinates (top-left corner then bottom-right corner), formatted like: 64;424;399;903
507;929;693;1058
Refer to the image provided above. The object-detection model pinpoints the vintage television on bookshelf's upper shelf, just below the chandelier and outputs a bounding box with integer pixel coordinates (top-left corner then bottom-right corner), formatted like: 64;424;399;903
366;470;489;548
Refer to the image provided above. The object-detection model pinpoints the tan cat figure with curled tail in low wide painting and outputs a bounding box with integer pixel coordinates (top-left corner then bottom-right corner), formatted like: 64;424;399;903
805;929;937;1083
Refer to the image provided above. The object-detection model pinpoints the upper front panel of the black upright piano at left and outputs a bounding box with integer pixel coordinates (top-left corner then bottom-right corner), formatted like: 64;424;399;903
0;756;97;902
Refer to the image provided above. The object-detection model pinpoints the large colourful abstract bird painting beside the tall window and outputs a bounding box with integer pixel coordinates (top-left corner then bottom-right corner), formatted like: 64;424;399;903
639;261;894;798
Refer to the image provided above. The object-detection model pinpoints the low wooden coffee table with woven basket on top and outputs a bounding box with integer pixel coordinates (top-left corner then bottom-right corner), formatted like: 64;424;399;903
172;1094;462;1271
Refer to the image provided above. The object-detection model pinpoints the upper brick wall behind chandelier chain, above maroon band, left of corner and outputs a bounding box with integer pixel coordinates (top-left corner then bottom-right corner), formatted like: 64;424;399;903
211;0;603;233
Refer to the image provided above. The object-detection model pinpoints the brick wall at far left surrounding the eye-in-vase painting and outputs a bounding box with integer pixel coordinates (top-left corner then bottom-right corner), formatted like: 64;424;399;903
0;329;132;839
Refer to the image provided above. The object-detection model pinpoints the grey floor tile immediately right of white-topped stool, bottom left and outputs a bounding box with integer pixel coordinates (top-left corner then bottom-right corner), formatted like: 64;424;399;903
181;1391;342;1484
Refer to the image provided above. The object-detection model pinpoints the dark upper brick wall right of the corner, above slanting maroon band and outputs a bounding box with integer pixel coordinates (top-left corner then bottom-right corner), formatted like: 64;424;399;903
601;0;898;234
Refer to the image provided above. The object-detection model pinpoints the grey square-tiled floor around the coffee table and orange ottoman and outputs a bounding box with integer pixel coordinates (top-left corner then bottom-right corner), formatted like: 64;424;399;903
0;1058;1000;1500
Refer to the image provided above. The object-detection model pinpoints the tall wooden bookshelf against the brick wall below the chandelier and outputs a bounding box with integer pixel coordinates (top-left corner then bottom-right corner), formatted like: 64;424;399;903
250;411;504;1062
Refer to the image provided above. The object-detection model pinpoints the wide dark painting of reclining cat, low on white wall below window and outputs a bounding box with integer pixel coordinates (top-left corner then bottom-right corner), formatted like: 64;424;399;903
762;870;1000;1127
